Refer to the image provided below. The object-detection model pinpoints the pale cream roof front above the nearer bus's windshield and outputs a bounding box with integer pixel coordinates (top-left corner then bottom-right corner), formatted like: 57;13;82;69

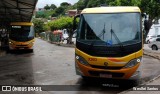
81;6;141;14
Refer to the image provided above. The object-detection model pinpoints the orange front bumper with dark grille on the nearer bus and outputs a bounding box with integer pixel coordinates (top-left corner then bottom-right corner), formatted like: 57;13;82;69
75;61;140;79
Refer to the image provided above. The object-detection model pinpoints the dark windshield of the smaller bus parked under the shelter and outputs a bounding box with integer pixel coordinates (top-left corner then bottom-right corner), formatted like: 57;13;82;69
10;26;34;41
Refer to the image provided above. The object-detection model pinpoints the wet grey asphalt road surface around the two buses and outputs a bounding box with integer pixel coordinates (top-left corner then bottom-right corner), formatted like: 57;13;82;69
0;39;160;94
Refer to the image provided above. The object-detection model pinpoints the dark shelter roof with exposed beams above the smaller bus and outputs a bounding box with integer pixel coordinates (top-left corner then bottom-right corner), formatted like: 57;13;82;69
0;0;38;23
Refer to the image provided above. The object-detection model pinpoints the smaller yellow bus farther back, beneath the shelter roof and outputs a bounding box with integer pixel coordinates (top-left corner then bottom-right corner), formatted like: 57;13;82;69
9;22;35;51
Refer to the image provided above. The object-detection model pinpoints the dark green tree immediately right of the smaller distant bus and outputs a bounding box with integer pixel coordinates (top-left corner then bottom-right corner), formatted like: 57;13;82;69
32;19;44;35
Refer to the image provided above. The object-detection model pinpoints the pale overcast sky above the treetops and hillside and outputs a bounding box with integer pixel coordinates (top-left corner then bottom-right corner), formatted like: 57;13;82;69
37;0;78;8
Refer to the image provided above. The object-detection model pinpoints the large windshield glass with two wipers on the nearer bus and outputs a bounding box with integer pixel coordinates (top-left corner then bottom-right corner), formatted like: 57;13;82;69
77;13;141;45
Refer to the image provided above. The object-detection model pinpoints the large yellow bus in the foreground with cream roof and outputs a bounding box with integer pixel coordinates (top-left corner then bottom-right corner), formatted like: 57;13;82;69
74;7;143;79
